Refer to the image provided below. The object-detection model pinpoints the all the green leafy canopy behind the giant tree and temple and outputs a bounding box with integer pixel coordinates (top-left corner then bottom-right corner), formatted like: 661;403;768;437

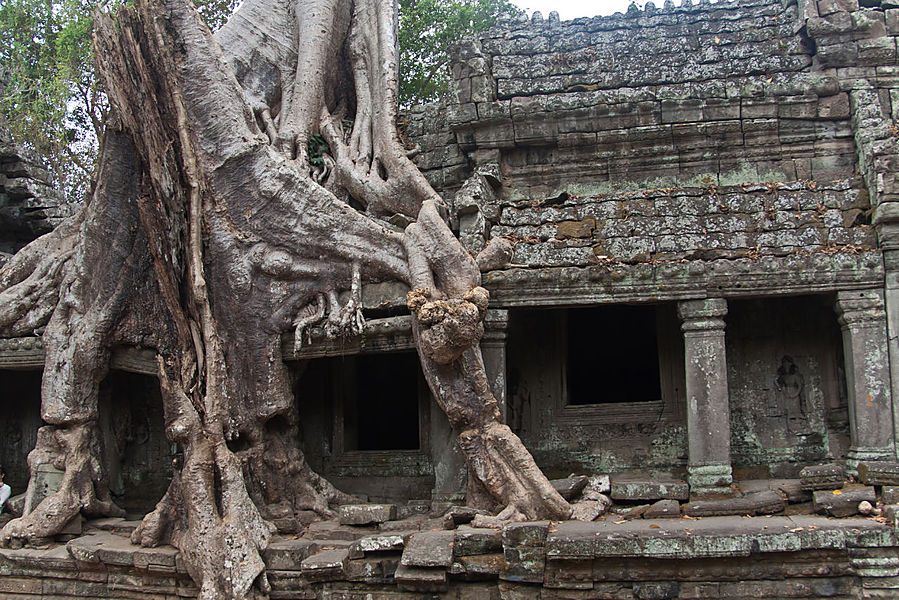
0;0;521;202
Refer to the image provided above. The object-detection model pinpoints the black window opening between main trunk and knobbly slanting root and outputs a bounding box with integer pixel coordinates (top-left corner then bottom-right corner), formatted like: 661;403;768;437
344;352;421;450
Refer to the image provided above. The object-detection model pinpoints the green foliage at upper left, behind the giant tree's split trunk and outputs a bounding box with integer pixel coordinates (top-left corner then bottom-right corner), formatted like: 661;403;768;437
0;0;237;202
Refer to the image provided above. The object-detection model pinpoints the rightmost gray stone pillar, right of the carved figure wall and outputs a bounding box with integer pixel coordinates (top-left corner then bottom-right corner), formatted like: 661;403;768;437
835;289;896;473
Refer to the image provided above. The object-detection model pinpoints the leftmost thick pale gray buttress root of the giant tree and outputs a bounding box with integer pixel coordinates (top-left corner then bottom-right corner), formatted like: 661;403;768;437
0;132;147;545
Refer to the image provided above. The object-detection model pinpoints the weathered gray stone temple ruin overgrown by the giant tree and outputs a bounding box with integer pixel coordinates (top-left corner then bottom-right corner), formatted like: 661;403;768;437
7;0;899;600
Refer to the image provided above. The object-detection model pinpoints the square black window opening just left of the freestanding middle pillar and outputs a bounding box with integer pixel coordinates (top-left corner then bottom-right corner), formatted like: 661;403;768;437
566;306;662;406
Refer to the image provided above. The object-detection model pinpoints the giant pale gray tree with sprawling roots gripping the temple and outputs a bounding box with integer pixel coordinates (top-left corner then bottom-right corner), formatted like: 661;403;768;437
0;0;570;598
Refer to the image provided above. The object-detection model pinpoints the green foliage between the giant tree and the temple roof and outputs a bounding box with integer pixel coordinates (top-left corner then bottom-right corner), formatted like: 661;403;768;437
399;0;521;106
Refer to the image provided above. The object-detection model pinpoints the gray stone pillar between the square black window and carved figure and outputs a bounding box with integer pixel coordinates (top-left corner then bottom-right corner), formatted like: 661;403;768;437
677;298;733;495
